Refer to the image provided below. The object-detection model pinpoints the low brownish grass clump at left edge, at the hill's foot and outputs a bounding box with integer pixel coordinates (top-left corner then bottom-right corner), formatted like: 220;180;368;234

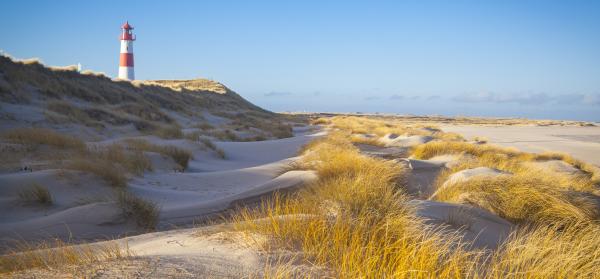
2;128;85;149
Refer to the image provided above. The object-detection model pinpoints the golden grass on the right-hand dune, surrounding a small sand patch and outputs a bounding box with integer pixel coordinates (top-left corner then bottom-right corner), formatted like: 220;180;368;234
412;141;600;224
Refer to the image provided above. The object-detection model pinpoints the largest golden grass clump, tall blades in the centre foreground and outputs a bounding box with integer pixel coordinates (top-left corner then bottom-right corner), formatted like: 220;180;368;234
234;135;479;278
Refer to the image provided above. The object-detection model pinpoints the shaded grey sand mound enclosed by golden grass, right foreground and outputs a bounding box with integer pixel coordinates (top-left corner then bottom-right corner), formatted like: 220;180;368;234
410;200;513;249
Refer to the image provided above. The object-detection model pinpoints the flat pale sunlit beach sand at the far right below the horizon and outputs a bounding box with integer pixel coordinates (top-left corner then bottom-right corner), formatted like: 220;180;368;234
441;125;600;166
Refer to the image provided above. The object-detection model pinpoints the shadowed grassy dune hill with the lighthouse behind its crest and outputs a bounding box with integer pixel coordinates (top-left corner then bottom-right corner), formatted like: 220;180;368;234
0;56;292;140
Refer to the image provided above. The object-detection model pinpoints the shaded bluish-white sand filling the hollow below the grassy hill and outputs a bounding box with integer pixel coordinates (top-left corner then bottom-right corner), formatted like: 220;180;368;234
0;131;321;245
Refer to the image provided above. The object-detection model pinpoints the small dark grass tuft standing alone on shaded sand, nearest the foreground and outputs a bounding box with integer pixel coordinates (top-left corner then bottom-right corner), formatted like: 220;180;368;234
117;191;160;231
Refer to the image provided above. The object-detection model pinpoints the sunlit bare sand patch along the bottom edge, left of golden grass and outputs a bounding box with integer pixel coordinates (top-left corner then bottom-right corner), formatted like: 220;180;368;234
7;226;326;278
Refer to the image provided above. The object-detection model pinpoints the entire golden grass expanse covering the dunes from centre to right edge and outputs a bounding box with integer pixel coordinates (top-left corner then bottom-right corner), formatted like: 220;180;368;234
232;116;600;278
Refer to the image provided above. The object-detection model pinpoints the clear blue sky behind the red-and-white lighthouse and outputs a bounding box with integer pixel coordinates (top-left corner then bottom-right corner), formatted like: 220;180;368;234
0;0;600;121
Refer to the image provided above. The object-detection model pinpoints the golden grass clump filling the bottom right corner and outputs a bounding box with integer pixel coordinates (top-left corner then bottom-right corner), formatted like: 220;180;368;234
485;222;600;278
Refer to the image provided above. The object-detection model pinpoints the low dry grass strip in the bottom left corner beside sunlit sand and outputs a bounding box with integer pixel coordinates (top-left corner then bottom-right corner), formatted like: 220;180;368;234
0;239;131;277
